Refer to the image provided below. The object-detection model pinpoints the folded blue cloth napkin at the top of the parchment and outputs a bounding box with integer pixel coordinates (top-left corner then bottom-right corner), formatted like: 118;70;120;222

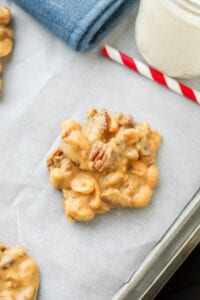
13;0;138;52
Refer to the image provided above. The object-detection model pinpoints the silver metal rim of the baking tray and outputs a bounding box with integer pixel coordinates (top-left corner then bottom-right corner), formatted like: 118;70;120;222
113;188;200;300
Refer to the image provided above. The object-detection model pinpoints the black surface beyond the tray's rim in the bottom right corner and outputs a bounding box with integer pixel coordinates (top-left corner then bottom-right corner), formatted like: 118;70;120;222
155;244;200;300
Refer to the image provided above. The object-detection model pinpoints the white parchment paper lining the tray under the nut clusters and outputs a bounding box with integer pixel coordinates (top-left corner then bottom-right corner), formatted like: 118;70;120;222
0;1;200;300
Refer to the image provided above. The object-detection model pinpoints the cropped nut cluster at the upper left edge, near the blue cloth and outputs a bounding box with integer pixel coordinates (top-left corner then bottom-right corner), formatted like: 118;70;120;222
0;6;14;90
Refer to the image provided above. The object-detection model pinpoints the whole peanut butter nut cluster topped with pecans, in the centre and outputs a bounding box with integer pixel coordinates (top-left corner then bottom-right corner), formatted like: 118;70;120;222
47;109;161;221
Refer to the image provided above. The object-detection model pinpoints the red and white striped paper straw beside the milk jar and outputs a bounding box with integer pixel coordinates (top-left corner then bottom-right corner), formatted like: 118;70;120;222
102;46;200;104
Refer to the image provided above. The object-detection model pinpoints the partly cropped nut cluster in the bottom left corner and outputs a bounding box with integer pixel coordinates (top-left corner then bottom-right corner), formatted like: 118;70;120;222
0;245;40;300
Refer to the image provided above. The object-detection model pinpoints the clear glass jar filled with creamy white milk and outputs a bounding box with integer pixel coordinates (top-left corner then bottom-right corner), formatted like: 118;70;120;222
136;0;200;78
